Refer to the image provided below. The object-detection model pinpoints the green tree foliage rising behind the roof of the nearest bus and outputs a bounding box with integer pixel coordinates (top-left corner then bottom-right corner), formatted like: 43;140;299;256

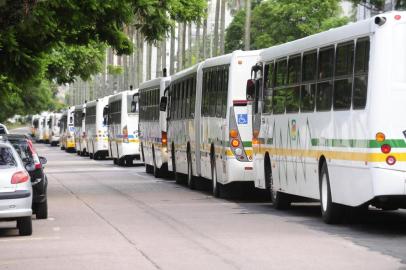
226;0;348;51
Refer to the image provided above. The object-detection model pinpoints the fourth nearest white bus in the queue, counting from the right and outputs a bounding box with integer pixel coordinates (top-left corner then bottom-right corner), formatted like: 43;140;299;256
103;89;140;166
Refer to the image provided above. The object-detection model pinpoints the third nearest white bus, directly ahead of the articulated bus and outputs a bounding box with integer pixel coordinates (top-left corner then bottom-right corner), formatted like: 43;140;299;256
139;77;171;177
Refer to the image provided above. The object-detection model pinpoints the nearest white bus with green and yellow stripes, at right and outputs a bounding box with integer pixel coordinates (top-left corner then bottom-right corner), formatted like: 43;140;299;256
247;12;406;223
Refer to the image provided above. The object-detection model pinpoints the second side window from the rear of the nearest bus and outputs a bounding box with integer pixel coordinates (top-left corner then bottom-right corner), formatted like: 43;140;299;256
333;42;354;110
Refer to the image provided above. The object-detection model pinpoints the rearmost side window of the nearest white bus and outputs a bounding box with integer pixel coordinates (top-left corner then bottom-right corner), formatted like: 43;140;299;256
352;37;370;110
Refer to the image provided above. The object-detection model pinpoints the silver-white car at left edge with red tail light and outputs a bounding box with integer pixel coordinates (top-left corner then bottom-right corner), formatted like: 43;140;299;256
0;140;32;235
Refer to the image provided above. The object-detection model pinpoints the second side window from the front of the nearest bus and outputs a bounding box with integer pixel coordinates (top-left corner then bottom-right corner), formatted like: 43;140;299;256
272;58;287;114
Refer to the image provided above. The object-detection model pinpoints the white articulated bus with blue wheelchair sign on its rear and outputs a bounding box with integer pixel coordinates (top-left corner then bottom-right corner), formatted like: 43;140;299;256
163;51;259;196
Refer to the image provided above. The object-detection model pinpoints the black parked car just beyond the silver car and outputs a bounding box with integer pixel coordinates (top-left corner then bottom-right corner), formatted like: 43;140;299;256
6;134;48;219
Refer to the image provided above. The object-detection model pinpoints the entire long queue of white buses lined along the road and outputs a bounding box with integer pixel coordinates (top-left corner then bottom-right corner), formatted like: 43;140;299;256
32;12;406;224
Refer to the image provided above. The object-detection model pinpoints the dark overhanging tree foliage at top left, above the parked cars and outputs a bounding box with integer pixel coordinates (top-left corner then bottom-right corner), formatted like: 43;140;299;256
0;0;206;121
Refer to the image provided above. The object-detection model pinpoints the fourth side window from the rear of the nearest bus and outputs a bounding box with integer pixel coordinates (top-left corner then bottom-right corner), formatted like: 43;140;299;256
300;51;317;112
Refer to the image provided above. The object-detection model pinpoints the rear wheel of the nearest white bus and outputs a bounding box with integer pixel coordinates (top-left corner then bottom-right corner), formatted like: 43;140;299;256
320;162;344;224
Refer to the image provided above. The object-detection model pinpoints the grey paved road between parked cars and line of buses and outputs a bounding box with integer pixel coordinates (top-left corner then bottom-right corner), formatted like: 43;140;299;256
0;127;406;270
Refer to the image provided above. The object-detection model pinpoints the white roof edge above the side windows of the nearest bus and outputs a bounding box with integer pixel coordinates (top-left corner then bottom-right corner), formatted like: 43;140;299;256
260;16;374;61
